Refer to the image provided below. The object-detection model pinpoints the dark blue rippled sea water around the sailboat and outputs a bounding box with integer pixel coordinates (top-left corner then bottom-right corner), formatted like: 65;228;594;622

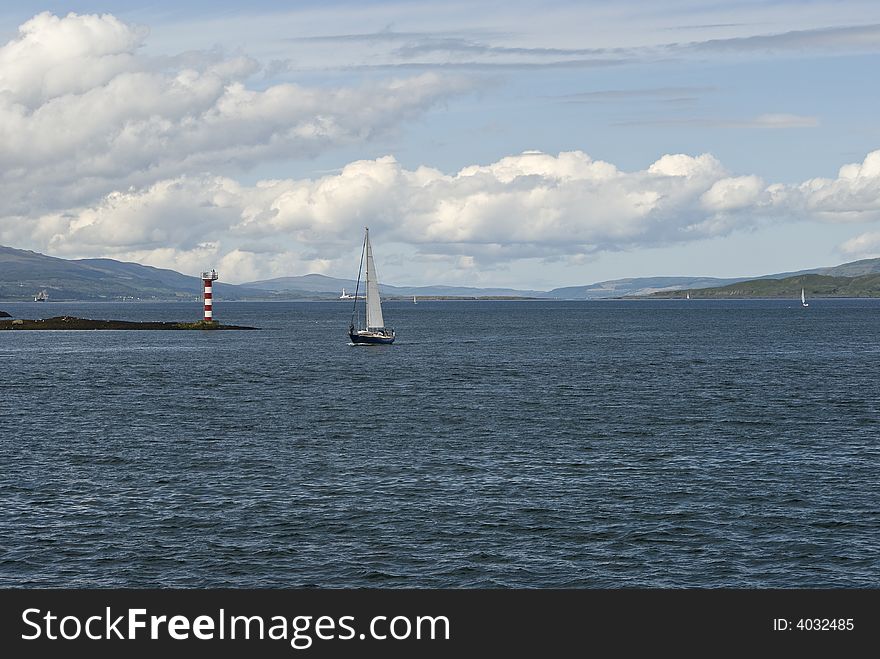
0;300;880;587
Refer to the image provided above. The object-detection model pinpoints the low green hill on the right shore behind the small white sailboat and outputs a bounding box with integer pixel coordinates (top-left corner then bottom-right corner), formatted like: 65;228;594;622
651;264;880;300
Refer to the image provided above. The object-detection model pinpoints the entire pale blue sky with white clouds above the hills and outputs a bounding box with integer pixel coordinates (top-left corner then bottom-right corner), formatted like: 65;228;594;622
0;0;880;290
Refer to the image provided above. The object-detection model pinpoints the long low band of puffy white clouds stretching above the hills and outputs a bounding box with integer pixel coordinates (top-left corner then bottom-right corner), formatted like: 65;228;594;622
8;151;880;279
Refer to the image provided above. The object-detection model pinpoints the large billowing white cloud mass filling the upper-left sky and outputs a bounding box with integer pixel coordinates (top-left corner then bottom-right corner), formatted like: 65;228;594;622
0;13;470;216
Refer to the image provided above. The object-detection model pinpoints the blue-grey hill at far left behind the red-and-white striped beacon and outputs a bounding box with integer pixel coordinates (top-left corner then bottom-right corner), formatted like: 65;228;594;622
0;246;267;301
